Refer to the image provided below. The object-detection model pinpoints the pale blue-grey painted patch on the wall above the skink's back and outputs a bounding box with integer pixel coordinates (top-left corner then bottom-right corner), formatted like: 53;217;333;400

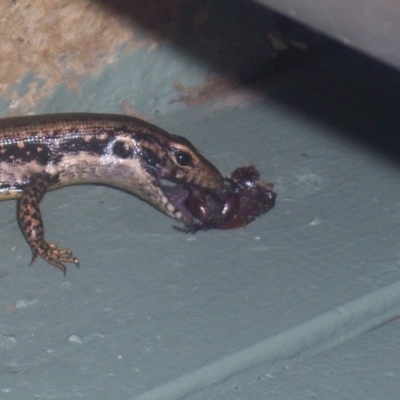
37;45;209;115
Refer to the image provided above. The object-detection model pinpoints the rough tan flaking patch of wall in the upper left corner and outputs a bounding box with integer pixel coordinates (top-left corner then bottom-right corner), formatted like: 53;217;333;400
0;0;136;114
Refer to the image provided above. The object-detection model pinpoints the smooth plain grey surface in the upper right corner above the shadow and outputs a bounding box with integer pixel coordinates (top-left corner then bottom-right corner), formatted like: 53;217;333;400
258;0;400;68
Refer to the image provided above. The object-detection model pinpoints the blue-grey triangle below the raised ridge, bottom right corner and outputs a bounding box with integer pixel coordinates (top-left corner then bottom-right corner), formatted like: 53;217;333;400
187;321;400;400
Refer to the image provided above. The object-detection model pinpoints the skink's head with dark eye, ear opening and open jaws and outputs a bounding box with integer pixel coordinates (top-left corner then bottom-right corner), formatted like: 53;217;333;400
94;118;224;224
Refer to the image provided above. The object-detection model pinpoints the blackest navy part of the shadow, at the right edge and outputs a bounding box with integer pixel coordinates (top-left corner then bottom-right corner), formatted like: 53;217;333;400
254;45;400;161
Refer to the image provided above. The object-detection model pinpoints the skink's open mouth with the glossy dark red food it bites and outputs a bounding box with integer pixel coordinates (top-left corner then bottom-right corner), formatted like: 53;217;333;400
146;165;276;233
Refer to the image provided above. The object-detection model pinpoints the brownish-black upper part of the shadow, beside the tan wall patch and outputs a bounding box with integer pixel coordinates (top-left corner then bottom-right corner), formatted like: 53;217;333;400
93;0;322;81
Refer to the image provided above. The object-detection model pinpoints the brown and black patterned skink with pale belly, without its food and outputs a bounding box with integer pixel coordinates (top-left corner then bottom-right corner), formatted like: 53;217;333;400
0;113;224;274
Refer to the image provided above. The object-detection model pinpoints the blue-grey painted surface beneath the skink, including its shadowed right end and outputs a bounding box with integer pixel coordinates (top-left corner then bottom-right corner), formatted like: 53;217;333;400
0;38;400;400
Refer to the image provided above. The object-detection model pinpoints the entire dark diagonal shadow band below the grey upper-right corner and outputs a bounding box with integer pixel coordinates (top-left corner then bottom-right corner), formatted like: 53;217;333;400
98;0;400;160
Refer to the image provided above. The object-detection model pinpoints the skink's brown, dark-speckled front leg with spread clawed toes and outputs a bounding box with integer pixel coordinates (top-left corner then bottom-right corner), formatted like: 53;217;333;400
17;174;79;275
